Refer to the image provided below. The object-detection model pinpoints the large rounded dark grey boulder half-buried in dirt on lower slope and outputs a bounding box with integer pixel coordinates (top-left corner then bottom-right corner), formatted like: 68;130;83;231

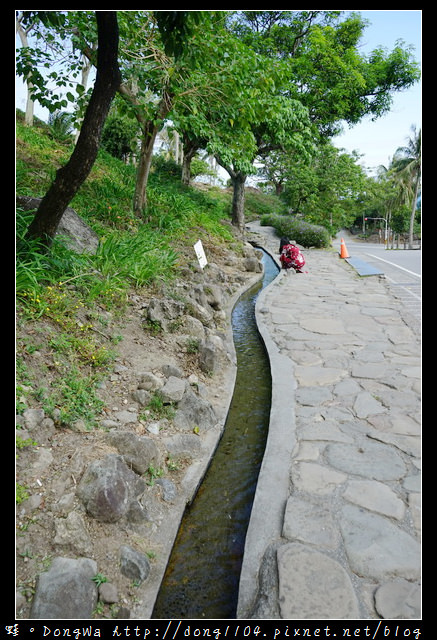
77;455;145;522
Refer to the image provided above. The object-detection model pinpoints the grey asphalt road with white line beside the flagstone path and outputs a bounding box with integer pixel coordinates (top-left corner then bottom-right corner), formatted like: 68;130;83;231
334;232;422;336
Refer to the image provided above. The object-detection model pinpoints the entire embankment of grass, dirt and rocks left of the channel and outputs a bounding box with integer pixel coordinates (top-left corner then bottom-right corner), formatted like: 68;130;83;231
16;116;280;618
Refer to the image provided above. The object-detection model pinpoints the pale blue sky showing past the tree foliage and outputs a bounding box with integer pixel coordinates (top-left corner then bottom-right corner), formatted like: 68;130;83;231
15;9;422;174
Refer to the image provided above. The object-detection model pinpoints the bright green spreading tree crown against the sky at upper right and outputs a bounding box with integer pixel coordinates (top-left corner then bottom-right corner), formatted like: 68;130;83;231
233;11;420;137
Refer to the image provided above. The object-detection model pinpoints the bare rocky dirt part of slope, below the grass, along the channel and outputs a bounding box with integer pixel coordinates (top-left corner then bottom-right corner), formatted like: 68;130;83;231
16;231;261;619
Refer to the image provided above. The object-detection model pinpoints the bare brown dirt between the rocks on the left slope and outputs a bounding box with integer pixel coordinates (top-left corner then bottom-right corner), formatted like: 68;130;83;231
16;235;260;619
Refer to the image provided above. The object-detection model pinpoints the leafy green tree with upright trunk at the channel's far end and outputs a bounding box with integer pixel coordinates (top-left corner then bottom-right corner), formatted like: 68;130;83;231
172;24;312;229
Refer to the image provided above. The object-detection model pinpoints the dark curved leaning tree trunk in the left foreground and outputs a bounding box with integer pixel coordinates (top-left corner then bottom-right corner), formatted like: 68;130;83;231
27;11;121;246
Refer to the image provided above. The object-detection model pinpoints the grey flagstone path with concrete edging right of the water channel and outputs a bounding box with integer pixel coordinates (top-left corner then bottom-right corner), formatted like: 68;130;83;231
238;224;421;619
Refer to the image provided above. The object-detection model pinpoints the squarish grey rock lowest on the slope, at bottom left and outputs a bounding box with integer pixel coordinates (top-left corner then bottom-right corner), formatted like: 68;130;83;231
30;558;97;620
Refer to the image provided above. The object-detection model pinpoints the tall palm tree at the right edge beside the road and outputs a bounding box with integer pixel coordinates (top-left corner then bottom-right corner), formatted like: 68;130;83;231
392;125;422;249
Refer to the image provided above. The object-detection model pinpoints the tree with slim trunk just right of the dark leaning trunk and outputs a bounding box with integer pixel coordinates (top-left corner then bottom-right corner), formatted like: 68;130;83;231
119;11;223;217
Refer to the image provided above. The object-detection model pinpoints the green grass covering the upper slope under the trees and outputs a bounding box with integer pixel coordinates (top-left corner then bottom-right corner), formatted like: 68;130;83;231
16;114;277;429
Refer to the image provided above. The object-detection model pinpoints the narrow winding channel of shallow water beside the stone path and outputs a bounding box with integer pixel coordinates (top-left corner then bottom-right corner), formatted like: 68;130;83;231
152;252;278;620
